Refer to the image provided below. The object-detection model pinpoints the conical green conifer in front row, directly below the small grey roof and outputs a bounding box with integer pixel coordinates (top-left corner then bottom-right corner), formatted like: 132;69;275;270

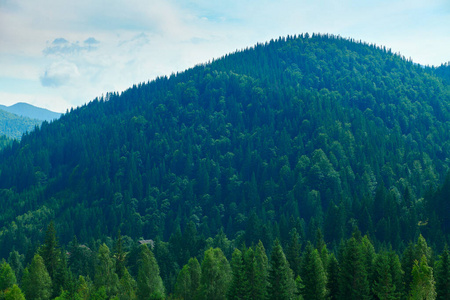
136;245;165;300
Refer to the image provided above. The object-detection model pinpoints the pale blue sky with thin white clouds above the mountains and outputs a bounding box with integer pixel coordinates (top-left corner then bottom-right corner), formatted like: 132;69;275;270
0;0;450;112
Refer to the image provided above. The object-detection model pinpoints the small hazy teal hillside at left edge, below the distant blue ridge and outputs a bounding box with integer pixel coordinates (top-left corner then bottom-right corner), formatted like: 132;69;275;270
0;108;42;139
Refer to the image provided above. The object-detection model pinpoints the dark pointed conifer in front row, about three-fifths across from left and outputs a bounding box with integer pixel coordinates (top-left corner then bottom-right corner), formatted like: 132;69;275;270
268;240;296;300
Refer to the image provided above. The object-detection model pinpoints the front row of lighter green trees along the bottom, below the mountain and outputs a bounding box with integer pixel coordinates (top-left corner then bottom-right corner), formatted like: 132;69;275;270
0;223;450;300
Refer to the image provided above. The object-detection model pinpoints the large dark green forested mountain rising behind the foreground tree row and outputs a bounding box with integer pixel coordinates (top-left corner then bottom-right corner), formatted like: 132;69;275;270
0;35;450;255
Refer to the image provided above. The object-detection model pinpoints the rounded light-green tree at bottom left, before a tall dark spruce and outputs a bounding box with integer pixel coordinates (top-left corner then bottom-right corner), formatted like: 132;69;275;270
22;254;52;300
